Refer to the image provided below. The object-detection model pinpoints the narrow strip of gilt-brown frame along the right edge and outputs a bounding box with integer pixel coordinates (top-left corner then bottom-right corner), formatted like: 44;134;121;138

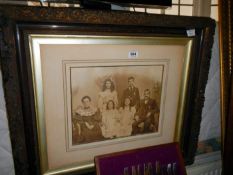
219;0;233;174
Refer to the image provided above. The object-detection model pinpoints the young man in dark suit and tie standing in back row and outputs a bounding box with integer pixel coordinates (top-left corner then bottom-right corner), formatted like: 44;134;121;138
122;77;140;110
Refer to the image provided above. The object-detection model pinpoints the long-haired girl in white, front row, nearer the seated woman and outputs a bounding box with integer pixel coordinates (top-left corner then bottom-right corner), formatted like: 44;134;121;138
101;100;120;138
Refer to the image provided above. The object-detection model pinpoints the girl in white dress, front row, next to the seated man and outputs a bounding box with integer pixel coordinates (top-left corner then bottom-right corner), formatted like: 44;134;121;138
118;97;136;137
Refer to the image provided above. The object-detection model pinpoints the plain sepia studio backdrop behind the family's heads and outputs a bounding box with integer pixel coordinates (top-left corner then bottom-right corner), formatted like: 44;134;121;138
71;65;163;111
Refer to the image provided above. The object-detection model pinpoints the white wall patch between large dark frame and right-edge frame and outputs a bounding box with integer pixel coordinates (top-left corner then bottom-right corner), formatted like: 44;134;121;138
199;24;221;141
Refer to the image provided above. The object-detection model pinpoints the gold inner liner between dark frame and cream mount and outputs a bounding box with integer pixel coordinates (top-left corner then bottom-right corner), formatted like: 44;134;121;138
29;34;193;175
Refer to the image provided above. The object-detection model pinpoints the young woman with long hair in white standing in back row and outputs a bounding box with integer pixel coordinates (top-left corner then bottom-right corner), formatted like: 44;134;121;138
98;79;118;112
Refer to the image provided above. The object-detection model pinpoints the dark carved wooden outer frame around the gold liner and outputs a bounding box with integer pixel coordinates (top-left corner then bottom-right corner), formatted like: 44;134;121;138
0;6;215;175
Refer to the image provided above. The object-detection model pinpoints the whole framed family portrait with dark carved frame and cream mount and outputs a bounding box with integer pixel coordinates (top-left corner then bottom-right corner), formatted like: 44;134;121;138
0;6;215;175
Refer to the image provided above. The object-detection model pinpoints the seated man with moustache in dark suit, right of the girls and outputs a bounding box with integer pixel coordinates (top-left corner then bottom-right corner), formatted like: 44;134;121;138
132;89;159;134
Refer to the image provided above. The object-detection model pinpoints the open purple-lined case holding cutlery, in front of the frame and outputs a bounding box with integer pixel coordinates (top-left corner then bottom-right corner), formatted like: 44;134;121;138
95;143;187;175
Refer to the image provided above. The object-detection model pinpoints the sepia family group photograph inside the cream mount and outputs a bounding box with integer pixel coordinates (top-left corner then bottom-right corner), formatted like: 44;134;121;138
70;64;164;145
